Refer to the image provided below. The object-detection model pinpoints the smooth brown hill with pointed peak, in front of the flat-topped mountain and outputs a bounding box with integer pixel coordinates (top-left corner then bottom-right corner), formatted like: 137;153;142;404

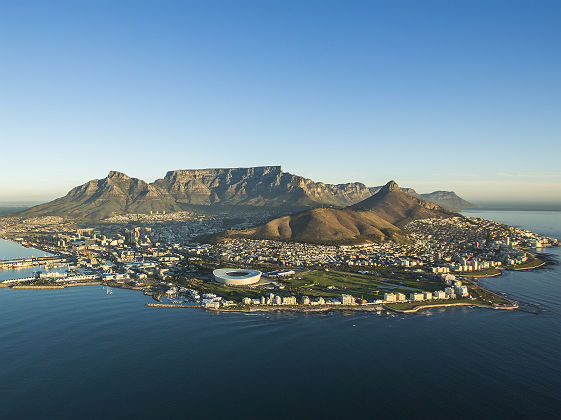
225;181;457;244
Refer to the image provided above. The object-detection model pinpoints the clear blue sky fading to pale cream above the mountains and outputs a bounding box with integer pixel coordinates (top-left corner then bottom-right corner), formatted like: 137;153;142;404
0;0;561;203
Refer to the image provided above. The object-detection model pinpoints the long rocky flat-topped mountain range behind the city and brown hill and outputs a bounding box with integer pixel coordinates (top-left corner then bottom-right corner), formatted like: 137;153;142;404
16;166;474;219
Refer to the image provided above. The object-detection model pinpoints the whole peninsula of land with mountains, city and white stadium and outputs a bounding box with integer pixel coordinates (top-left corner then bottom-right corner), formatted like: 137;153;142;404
0;167;559;312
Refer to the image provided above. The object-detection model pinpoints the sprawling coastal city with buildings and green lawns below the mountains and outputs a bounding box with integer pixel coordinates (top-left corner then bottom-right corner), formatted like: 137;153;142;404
0;212;559;310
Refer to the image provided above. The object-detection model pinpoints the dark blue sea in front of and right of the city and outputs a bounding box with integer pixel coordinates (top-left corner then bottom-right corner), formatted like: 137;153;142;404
0;212;561;419
